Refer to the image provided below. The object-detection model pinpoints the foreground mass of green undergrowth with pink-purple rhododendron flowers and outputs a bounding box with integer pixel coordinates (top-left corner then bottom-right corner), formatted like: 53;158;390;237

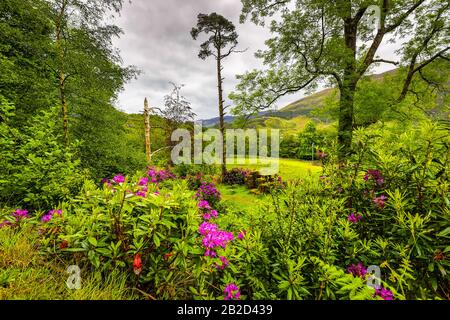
0;118;450;300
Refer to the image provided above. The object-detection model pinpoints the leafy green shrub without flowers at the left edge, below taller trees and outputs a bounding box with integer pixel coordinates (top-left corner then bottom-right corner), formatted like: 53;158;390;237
0;99;84;209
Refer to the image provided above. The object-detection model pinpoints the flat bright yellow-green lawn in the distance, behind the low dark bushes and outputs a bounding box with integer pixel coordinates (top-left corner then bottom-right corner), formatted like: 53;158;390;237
227;159;322;180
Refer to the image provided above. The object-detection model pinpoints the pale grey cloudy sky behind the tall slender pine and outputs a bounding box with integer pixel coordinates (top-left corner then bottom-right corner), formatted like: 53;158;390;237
110;0;400;119
